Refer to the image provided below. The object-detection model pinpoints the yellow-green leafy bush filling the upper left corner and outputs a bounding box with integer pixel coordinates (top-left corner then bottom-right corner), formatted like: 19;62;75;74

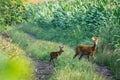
0;0;27;25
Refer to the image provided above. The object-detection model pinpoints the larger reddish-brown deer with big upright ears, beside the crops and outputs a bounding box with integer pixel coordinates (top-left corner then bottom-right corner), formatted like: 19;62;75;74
73;37;99;61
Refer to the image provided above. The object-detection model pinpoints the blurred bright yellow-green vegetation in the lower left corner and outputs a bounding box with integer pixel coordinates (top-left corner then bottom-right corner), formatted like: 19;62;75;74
0;37;34;80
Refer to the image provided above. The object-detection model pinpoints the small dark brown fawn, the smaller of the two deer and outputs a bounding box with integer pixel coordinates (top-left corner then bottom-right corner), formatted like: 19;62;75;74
49;46;64;65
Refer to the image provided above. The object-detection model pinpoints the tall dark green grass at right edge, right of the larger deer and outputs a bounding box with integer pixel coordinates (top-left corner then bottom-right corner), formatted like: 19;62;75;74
96;49;120;80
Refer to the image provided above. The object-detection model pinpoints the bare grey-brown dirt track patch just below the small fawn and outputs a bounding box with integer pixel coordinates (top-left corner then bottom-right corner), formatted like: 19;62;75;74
31;57;54;80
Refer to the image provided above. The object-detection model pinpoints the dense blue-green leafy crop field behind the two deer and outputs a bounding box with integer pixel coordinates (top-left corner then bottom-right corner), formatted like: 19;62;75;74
24;0;120;47
